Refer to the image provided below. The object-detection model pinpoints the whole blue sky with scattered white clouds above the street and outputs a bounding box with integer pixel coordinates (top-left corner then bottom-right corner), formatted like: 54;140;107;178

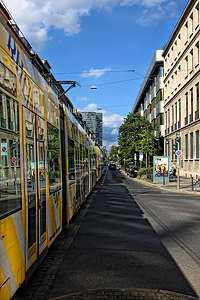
4;0;188;149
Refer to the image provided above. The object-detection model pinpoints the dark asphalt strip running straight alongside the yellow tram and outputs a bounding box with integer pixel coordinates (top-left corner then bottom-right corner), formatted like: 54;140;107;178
48;171;195;298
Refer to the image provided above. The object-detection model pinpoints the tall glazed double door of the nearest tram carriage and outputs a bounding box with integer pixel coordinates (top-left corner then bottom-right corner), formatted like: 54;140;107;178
24;108;47;269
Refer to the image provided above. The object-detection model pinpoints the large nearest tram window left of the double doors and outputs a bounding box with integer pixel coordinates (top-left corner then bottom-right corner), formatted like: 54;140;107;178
0;99;21;219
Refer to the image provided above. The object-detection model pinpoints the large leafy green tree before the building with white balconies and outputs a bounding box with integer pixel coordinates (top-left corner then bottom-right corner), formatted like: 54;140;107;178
118;113;157;162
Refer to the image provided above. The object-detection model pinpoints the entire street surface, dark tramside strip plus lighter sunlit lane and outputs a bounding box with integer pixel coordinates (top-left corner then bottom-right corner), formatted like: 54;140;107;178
13;170;200;300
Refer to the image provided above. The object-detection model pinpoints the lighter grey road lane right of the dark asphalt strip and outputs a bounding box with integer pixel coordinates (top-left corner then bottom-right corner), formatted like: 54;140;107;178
123;175;200;297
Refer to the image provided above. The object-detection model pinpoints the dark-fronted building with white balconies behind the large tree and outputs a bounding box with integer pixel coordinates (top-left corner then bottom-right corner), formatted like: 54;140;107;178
131;50;164;155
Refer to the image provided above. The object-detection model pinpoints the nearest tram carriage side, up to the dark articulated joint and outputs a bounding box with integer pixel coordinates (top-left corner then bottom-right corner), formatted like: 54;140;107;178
0;24;62;299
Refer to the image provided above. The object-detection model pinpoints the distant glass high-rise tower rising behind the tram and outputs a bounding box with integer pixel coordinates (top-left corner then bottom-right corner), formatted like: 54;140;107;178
80;111;103;146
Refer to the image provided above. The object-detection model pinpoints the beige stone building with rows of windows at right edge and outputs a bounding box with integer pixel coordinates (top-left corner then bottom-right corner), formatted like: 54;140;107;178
163;0;200;178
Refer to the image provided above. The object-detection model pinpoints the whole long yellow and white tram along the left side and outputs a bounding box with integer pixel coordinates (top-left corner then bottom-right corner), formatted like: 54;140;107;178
0;4;103;300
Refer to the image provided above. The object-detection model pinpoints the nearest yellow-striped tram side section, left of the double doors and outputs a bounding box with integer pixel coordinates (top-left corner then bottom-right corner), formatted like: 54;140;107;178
0;47;26;299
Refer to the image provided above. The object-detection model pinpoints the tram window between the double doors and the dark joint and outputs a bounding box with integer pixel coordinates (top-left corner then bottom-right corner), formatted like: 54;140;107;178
47;123;61;194
